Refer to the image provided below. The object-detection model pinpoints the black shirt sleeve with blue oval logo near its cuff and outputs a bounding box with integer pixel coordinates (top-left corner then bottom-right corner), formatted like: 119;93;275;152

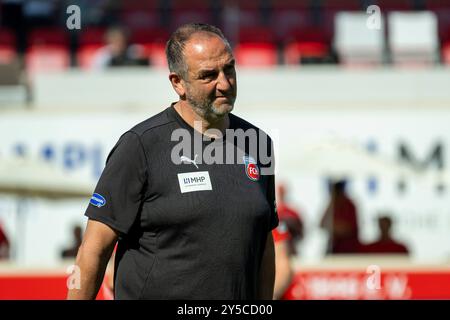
85;131;148;234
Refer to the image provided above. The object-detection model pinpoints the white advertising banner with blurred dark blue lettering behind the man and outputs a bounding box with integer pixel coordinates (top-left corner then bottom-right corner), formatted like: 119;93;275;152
0;105;450;264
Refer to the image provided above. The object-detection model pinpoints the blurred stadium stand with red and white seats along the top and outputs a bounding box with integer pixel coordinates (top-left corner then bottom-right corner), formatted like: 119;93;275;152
0;0;450;73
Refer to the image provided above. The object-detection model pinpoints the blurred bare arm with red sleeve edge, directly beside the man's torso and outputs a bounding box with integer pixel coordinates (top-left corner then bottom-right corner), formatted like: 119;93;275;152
272;221;294;300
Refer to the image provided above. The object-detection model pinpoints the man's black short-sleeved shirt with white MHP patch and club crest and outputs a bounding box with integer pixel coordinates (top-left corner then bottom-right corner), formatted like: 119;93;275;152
82;106;278;299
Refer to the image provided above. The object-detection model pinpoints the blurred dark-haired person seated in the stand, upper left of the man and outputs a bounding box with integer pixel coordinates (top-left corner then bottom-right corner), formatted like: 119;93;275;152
94;26;149;69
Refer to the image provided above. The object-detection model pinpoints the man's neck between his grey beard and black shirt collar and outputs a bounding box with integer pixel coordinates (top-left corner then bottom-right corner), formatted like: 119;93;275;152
174;100;230;138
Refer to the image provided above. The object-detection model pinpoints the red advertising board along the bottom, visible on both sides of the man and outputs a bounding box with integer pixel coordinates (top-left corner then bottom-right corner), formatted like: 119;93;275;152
0;269;450;300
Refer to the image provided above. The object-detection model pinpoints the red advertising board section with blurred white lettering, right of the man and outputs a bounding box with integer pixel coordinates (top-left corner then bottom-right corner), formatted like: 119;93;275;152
284;270;450;300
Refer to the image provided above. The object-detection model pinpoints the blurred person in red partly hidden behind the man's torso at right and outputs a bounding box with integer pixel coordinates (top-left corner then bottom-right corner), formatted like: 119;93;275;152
277;183;304;255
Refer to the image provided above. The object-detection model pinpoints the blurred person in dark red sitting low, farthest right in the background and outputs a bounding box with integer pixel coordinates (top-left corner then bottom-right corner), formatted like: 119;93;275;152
360;215;409;254
